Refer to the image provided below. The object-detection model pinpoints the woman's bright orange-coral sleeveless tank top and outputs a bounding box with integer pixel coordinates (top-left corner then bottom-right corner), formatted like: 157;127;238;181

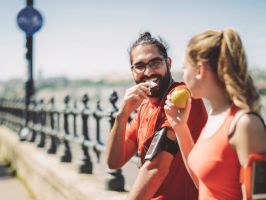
188;106;242;200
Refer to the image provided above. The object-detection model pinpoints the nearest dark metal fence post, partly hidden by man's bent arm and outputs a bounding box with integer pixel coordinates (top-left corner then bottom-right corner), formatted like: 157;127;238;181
105;91;125;191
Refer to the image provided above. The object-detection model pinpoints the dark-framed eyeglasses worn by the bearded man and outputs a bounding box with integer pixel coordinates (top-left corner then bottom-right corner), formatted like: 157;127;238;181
132;57;165;73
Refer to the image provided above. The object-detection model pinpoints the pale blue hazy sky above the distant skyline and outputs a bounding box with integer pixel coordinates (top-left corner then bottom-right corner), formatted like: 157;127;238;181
0;0;266;81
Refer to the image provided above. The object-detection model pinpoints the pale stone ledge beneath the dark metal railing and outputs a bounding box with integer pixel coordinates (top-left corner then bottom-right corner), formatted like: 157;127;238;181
0;126;127;200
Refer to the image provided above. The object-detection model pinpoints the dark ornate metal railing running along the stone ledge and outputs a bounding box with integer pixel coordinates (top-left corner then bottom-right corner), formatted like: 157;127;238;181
0;91;138;191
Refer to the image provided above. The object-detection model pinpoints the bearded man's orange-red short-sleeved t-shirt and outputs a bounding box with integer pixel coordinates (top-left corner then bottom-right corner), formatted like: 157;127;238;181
126;83;207;200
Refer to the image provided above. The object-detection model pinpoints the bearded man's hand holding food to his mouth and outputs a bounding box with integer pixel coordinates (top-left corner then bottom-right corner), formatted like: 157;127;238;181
119;82;151;116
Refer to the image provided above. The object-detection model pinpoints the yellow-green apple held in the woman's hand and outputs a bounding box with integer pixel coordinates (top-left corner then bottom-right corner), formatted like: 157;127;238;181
171;88;190;108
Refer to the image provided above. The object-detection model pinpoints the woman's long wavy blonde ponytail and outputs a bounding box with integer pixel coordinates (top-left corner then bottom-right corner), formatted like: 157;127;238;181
217;29;261;113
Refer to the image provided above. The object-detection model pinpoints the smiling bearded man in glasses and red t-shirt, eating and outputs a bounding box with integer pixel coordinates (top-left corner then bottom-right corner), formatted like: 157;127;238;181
106;32;207;200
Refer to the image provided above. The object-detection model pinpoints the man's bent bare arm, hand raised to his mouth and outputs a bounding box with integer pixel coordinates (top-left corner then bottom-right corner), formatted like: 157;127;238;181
106;82;150;169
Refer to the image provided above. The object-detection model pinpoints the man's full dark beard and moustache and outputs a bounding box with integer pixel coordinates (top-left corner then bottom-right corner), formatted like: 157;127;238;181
135;68;171;97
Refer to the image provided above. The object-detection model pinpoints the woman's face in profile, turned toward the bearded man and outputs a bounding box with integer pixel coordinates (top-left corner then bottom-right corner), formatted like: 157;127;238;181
183;54;200;98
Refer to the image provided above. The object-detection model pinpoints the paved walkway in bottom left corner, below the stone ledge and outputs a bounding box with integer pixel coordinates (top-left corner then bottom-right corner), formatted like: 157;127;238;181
0;162;33;200
